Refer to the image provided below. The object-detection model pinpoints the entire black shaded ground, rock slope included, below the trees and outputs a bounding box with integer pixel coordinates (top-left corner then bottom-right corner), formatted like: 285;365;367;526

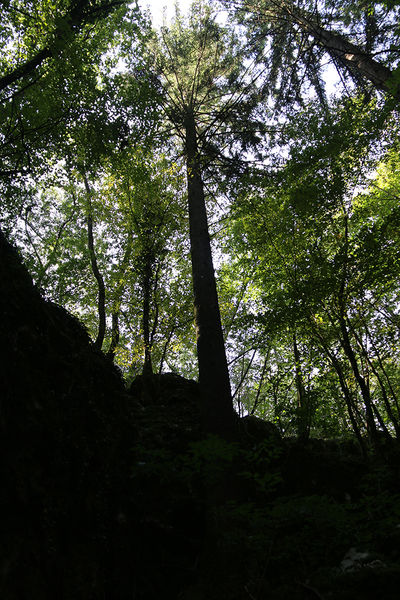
0;227;400;600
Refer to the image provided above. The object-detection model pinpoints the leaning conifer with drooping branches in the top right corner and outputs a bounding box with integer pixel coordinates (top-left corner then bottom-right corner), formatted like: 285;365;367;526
222;0;399;107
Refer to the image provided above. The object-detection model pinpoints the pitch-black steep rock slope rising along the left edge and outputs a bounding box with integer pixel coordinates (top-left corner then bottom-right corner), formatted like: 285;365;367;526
0;234;133;600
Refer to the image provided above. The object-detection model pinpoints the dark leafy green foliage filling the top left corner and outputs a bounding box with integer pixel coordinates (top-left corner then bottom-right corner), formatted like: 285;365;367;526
0;1;138;185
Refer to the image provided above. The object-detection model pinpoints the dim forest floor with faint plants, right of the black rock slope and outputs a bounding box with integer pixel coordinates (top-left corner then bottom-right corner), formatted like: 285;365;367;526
133;376;400;600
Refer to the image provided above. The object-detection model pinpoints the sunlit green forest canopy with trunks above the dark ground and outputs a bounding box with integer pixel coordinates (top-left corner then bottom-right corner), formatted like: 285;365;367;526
0;0;400;441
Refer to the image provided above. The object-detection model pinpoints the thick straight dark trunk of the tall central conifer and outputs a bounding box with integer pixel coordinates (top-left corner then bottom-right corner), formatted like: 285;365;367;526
184;110;234;436
